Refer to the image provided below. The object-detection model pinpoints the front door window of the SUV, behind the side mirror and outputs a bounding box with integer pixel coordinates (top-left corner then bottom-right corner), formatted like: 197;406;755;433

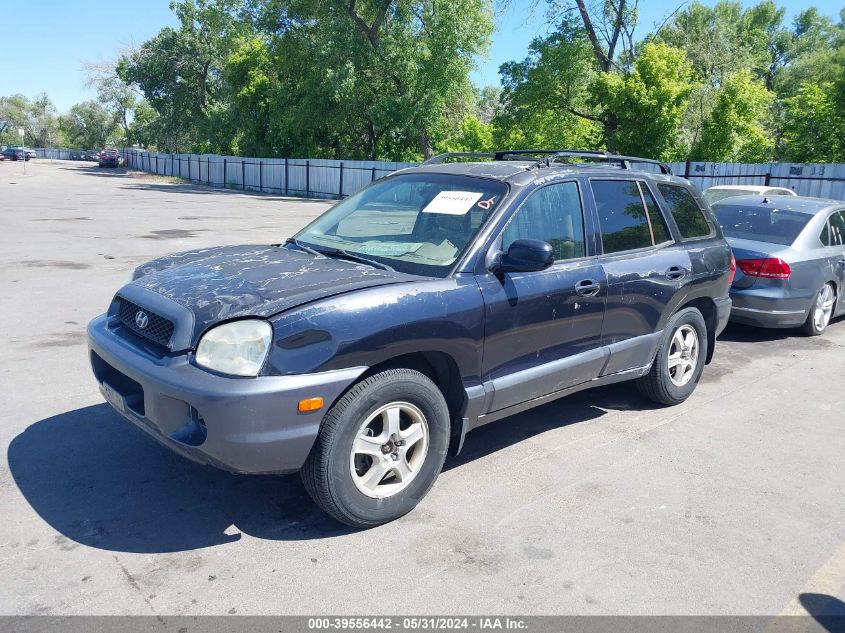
502;182;586;261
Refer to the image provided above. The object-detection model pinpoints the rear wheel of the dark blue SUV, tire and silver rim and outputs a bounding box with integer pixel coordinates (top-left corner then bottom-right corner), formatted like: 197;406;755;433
636;308;707;405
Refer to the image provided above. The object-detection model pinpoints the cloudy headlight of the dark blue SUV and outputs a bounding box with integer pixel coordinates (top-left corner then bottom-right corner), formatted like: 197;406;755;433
196;319;273;376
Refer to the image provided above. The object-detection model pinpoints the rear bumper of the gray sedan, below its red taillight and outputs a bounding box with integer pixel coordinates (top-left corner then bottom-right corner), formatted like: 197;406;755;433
731;286;812;328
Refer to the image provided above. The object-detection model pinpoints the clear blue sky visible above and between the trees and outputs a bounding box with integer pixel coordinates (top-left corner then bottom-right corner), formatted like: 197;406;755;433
0;0;843;112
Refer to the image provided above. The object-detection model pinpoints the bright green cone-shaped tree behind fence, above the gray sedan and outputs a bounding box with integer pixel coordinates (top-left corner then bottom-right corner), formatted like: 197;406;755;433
692;70;775;163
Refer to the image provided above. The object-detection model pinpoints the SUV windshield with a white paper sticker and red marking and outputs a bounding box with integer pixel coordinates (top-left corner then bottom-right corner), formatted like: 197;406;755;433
295;173;508;277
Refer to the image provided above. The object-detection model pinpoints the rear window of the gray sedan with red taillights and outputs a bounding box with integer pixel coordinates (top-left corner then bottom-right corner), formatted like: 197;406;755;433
713;207;813;245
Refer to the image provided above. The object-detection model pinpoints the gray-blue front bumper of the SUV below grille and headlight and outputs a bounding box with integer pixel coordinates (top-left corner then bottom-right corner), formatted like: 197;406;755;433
88;315;366;473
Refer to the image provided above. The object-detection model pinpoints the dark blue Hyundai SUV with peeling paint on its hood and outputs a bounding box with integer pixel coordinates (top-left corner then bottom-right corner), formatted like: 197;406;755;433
88;150;733;527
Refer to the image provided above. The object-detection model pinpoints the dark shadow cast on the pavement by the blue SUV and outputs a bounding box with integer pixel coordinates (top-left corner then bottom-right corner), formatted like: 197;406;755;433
7;385;650;553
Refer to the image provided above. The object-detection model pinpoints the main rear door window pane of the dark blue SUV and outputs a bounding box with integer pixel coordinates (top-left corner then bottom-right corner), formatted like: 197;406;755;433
590;180;659;254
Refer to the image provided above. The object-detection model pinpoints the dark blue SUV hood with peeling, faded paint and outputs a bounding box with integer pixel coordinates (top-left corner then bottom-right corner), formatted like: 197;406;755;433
132;245;419;341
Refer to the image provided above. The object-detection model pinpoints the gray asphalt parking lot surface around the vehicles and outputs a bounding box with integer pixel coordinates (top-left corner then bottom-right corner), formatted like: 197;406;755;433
0;160;845;615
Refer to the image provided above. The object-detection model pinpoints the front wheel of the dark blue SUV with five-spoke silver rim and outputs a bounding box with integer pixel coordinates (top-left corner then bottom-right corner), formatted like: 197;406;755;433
300;369;449;528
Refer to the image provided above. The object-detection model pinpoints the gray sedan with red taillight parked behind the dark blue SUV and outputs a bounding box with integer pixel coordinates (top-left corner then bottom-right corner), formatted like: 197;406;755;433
712;195;845;336
